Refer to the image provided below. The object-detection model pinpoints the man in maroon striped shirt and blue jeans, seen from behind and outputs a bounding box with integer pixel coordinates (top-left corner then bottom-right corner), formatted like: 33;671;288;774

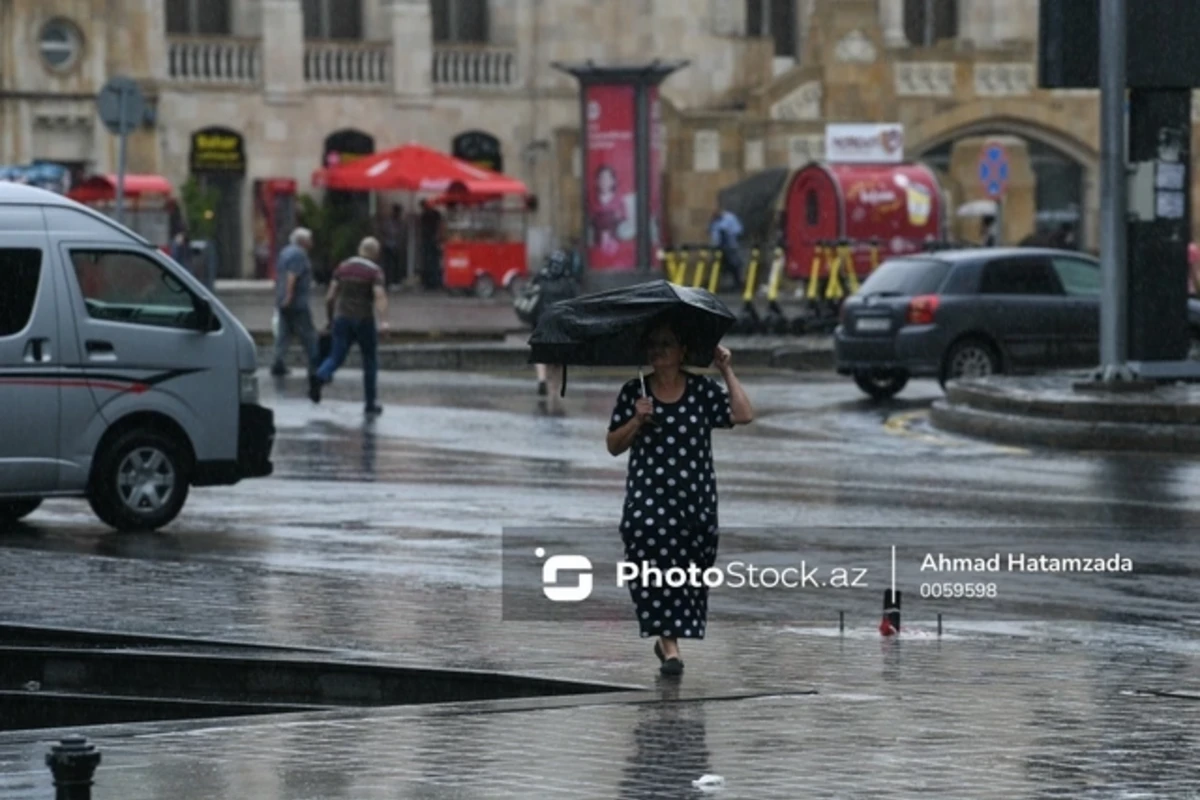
308;236;388;416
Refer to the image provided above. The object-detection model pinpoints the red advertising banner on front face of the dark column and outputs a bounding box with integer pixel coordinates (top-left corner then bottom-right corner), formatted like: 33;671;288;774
583;85;637;271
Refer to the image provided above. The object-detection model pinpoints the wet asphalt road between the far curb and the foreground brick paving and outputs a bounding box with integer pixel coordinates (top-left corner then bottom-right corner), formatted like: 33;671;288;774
0;372;1200;651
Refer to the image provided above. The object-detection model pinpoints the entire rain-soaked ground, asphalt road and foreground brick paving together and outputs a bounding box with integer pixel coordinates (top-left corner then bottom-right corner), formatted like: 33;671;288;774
0;372;1200;800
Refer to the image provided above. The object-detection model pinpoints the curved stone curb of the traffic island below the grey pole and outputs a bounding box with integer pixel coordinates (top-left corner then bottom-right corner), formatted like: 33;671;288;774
929;401;1200;455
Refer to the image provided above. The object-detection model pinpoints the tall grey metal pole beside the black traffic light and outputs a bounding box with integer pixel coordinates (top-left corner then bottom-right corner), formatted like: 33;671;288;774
1100;0;1129;371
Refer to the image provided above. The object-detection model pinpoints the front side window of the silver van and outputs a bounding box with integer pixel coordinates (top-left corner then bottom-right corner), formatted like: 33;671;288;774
71;249;205;329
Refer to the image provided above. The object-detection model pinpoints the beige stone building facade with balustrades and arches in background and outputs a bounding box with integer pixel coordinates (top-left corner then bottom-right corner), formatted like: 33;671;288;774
0;0;1200;276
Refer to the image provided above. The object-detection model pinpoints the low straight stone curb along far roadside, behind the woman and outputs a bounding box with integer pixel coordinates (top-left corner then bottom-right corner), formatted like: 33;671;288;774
258;342;834;372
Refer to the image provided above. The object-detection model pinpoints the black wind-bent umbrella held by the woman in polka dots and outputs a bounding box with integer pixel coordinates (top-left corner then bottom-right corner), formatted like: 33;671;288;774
529;281;737;392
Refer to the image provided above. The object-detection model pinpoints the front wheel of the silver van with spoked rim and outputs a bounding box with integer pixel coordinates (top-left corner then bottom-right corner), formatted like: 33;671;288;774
88;428;192;531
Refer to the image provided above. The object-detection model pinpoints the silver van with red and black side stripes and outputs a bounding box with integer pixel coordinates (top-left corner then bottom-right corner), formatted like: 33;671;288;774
0;182;275;531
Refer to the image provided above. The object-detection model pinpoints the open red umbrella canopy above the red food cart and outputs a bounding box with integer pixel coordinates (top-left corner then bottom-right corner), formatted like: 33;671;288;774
312;144;528;194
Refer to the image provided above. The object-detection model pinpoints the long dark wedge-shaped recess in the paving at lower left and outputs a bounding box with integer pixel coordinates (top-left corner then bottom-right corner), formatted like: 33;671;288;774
0;625;628;730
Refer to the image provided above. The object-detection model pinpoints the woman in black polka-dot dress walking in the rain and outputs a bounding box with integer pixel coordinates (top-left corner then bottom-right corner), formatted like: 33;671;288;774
607;321;754;675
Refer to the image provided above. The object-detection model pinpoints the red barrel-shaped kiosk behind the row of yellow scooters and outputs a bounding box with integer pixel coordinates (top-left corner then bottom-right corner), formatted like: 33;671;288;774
784;163;946;279
